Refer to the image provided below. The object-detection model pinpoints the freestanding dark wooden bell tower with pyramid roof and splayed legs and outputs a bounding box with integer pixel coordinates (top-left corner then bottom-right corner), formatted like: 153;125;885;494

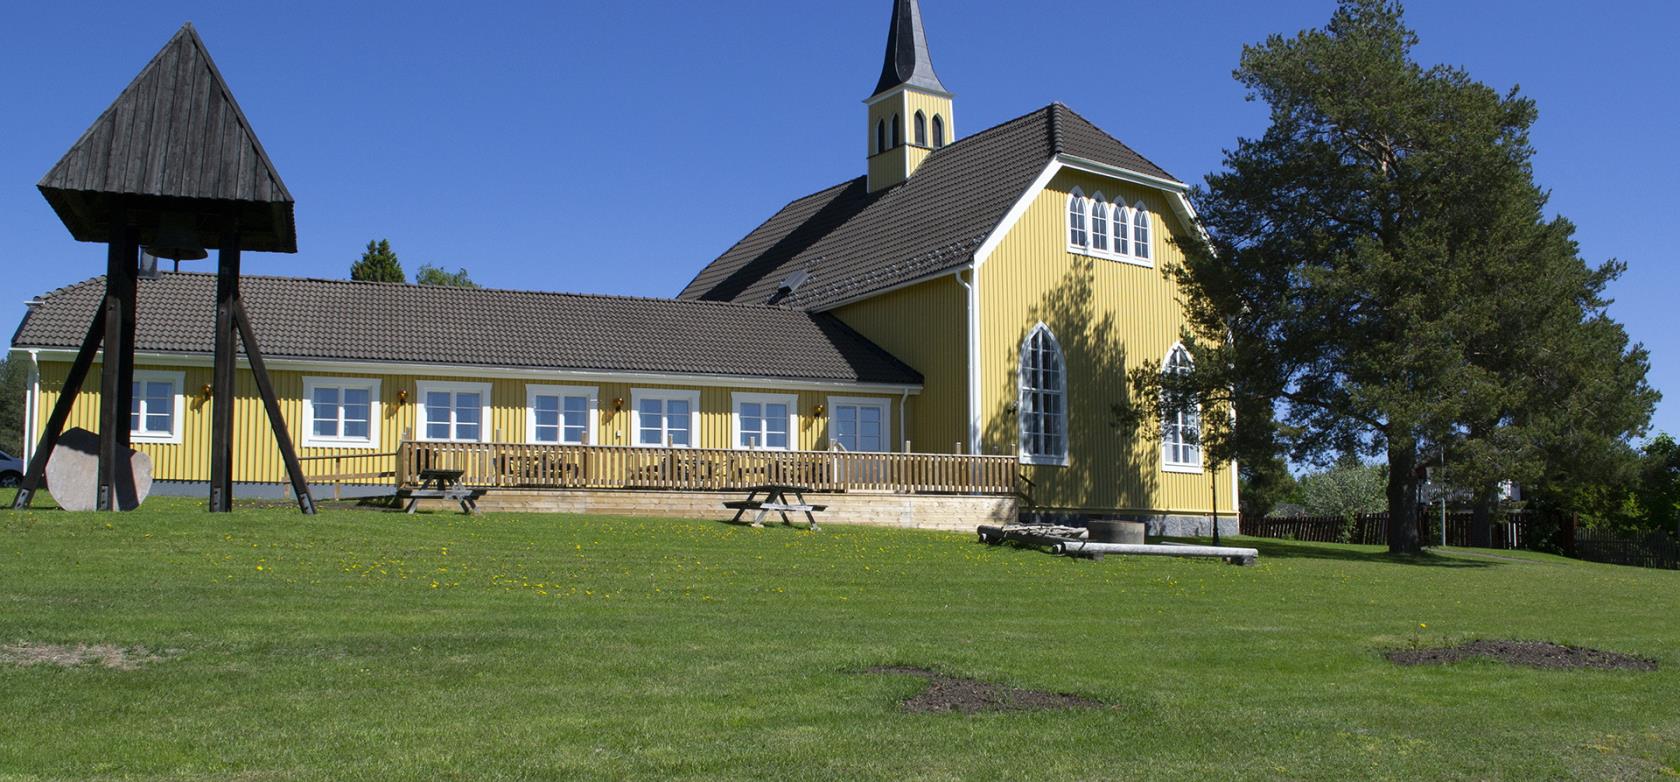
12;24;314;513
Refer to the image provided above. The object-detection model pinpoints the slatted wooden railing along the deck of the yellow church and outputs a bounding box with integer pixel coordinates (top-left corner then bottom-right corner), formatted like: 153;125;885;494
396;442;1016;494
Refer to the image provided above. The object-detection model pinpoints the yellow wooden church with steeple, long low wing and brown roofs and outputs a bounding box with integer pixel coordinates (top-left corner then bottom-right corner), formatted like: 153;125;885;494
12;0;1236;533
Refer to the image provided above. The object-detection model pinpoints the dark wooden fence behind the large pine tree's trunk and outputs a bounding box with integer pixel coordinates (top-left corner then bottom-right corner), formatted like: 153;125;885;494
1238;510;1542;548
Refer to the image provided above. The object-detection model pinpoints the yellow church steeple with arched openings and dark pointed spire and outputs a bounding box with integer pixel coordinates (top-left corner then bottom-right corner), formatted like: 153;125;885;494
864;0;956;192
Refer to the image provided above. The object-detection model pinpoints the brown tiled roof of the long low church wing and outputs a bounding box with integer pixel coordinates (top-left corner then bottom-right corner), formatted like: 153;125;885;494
12;272;922;385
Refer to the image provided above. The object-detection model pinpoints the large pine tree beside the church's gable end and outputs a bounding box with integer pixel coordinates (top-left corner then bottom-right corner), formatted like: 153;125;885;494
1132;0;1651;553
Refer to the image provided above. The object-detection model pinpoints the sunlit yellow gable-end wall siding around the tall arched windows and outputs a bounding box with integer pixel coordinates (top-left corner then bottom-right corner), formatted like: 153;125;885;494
981;170;1233;513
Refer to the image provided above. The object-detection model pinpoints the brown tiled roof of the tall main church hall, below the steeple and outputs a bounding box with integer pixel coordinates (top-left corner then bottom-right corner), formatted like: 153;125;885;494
679;103;1176;309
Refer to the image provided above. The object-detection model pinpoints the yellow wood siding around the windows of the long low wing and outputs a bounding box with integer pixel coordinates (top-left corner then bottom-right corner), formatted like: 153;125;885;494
34;358;900;483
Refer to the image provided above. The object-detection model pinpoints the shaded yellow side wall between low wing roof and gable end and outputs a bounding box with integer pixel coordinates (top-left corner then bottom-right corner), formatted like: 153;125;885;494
833;276;968;454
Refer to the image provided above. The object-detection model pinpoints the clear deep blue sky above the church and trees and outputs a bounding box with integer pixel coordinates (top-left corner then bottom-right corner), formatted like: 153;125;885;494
0;0;1680;432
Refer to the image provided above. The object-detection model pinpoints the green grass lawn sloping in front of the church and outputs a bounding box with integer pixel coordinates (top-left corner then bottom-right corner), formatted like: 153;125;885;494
0;498;1680;780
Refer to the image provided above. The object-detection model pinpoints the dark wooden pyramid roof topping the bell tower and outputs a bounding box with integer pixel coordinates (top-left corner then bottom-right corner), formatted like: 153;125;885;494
37;24;297;252
